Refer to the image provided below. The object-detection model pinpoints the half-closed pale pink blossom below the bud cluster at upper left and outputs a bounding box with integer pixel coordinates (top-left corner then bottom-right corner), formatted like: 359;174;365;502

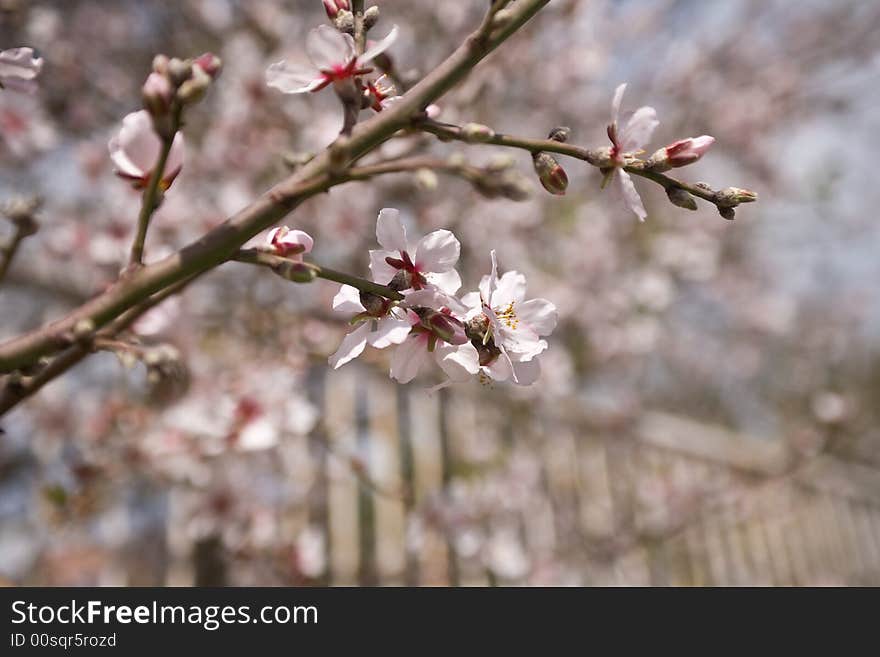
108;110;184;189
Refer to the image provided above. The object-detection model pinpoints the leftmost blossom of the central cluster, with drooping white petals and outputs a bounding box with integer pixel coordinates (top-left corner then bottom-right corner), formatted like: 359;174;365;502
329;285;418;369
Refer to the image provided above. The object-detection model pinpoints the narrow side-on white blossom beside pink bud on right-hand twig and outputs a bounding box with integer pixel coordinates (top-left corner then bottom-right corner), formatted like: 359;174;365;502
602;84;660;221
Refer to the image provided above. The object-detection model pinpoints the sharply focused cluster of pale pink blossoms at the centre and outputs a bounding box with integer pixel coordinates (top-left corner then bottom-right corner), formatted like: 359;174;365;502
318;208;557;385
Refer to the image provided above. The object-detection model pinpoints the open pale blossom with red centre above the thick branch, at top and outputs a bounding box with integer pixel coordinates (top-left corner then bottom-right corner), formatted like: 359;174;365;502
266;25;397;94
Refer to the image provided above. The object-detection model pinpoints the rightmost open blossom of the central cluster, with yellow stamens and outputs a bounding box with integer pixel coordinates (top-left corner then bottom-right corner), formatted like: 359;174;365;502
462;250;557;385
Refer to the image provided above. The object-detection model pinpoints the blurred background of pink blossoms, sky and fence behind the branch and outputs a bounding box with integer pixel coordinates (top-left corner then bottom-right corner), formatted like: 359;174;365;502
0;0;880;585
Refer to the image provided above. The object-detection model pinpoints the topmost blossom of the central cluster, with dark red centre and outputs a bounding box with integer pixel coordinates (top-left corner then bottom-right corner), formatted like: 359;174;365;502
370;208;461;295
